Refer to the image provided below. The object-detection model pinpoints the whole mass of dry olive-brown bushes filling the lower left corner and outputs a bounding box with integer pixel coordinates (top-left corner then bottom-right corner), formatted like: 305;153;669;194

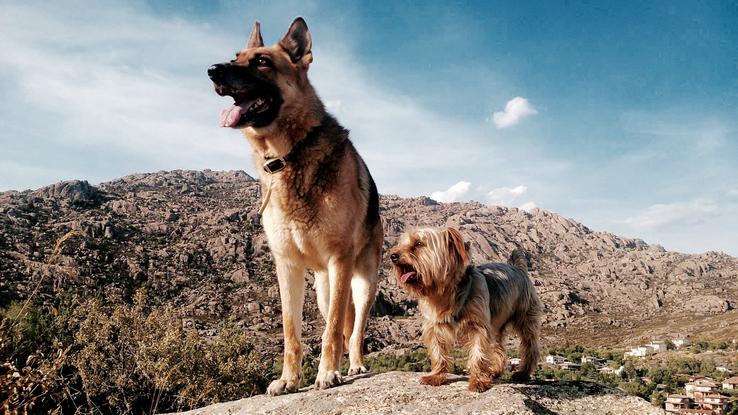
0;291;272;414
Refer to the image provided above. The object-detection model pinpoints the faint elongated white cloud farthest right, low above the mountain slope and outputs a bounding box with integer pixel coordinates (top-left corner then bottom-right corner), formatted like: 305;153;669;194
622;199;718;230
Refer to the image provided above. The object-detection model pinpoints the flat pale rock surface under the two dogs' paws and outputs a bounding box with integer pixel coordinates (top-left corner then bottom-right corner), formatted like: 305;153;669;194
165;372;664;415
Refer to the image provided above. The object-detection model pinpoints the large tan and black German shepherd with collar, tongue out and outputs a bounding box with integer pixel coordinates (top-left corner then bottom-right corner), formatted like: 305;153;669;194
208;17;383;395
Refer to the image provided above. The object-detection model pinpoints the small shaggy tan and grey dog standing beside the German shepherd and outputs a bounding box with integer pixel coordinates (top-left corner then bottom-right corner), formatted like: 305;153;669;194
390;228;542;392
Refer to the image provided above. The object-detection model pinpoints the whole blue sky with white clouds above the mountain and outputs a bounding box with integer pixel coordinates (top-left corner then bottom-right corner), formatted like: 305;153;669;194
0;0;738;255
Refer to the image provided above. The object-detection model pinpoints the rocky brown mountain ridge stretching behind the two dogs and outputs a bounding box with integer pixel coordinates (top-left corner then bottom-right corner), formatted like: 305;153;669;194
0;170;738;351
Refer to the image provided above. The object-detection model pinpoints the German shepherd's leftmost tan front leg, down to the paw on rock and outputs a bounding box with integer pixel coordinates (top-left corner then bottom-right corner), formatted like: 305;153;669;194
267;256;305;396
